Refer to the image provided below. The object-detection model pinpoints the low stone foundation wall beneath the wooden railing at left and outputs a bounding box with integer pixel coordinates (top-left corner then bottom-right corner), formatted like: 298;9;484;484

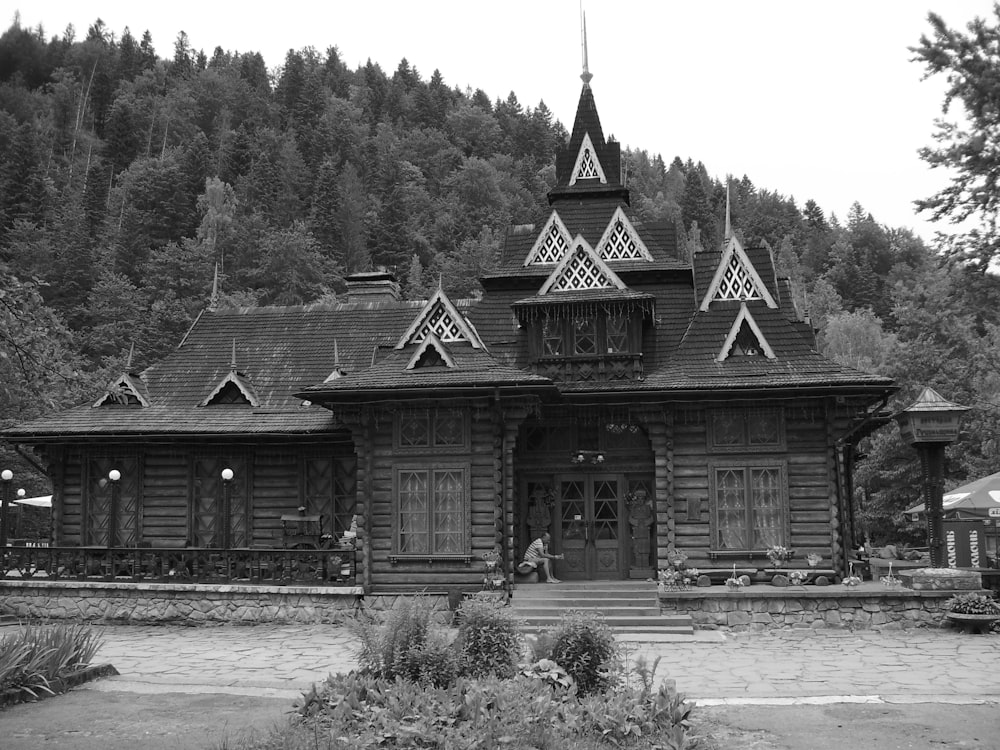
0;581;451;624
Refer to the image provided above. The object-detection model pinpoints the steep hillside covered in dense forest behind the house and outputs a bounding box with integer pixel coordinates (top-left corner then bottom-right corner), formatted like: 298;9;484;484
0;14;1000;536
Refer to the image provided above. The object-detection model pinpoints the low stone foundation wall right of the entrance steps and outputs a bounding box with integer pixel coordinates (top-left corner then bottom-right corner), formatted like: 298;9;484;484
660;586;955;631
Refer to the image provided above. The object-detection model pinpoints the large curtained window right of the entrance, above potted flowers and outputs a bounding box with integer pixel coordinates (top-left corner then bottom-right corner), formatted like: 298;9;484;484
709;461;788;552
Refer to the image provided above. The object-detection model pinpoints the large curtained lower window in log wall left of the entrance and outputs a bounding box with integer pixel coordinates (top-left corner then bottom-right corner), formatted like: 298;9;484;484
395;467;469;555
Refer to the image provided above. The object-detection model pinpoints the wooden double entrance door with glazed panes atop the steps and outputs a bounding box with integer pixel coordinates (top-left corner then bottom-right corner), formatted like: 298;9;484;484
553;474;626;580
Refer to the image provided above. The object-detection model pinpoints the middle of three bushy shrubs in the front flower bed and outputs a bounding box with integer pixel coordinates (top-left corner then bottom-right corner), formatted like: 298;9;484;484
457;598;522;678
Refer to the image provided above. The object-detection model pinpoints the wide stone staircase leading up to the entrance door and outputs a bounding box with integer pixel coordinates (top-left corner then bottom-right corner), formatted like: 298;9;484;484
510;581;694;637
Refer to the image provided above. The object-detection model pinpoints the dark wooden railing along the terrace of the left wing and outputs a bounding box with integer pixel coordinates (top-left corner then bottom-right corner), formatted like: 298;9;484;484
0;545;357;586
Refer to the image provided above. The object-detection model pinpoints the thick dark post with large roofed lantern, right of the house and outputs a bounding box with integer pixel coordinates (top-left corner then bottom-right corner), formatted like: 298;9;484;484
895;388;969;568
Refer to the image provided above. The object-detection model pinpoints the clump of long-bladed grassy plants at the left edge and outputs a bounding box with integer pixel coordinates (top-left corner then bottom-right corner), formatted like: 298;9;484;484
0;624;103;698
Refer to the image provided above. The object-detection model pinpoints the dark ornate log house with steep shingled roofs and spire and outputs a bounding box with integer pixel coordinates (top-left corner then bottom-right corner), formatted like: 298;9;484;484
4;76;894;593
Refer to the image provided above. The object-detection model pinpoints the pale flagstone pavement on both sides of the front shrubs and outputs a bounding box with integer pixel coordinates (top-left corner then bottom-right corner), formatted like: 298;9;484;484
76;625;1000;705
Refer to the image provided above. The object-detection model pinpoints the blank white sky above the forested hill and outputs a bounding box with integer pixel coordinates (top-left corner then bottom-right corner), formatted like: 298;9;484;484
11;0;993;239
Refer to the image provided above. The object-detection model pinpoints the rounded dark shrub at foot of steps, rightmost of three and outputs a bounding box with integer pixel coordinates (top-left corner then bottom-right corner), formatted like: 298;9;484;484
536;612;618;695
